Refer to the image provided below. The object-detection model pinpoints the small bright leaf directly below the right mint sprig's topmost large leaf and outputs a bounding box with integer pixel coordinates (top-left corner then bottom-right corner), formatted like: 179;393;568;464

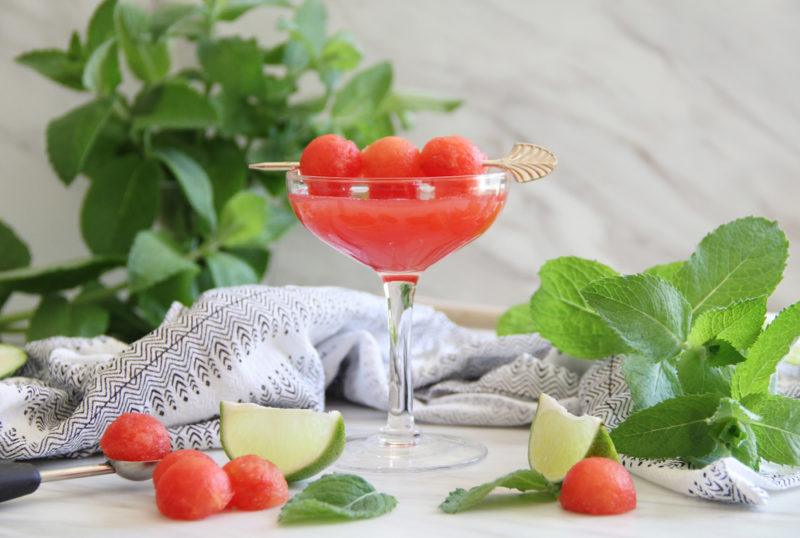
688;297;767;349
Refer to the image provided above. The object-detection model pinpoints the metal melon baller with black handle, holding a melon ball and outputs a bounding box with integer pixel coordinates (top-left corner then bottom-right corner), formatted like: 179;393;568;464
0;460;159;502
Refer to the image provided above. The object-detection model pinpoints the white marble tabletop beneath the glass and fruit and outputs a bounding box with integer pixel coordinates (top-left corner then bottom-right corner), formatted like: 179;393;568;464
0;405;800;538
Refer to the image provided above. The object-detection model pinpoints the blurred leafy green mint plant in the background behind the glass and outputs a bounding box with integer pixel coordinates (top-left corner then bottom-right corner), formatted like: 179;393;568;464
0;0;459;341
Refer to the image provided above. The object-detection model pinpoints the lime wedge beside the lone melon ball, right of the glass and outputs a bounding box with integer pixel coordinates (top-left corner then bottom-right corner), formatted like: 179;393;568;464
528;394;619;482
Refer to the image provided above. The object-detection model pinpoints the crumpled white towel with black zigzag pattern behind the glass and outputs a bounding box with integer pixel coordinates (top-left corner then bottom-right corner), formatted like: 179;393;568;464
0;286;800;504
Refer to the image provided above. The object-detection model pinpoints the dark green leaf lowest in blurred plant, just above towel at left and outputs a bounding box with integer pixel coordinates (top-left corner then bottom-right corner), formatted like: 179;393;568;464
26;295;109;340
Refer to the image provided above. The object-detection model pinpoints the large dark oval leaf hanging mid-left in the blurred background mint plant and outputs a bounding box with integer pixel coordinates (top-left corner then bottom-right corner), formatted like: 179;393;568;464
81;155;163;256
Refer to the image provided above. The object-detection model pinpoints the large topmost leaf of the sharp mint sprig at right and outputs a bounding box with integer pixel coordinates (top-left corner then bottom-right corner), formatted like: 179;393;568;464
678;217;789;315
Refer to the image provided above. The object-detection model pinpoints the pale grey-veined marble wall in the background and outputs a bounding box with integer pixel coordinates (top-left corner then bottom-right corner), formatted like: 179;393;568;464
0;0;800;307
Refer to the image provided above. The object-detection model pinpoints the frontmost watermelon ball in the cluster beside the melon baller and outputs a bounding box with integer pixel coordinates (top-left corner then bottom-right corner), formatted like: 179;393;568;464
156;457;233;519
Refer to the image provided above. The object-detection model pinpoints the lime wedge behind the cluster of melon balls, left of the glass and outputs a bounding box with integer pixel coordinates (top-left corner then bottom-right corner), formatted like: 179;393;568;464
219;402;344;482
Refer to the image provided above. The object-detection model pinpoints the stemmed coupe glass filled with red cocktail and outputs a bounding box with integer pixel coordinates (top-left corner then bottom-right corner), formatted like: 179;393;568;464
287;171;506;472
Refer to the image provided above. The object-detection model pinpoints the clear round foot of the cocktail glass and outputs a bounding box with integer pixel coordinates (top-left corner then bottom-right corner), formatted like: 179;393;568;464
336;433;486;473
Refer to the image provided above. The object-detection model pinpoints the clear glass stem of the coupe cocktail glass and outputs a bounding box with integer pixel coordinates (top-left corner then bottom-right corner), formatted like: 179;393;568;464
380;277;419;447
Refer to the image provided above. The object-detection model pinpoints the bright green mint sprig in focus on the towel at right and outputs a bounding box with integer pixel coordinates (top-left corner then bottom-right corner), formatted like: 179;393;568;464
498;217;800;469
